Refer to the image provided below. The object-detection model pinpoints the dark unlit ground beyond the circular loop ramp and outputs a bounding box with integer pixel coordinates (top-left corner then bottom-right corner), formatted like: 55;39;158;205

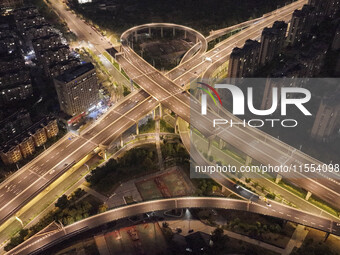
70;0;291;34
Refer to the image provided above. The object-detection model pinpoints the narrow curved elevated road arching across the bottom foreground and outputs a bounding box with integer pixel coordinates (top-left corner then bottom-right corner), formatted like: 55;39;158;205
8;197;340;255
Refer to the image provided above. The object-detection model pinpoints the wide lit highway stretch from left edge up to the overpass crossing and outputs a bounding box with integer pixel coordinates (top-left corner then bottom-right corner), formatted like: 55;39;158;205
0;90;157;223
